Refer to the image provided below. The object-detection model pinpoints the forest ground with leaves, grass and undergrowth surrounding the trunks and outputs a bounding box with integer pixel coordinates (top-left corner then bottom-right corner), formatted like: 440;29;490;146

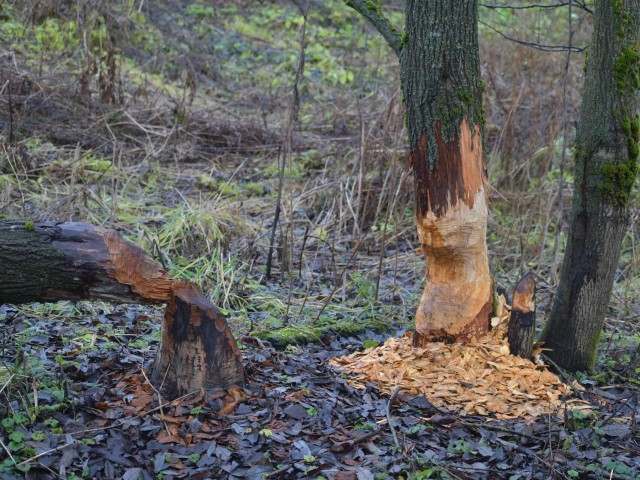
0;0;640;480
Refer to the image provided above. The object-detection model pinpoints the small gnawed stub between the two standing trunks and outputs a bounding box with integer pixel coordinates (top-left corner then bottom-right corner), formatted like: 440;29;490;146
507;272;536;358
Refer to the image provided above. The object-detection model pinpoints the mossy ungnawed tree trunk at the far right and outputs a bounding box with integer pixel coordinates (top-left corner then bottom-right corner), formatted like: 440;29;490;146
541;0;640;371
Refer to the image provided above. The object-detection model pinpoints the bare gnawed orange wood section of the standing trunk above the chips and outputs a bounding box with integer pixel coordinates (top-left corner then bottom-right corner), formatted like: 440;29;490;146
413;119;492;346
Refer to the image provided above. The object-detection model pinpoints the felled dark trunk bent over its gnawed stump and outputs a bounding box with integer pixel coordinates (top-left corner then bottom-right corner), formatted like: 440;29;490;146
0;221;244;398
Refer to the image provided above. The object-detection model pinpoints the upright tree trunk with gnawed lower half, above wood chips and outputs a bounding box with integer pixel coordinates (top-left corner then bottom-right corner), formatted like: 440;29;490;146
401;0;492;345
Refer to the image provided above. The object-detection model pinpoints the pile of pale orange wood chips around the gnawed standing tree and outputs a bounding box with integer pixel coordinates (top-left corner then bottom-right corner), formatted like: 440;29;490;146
330;326;578;418
